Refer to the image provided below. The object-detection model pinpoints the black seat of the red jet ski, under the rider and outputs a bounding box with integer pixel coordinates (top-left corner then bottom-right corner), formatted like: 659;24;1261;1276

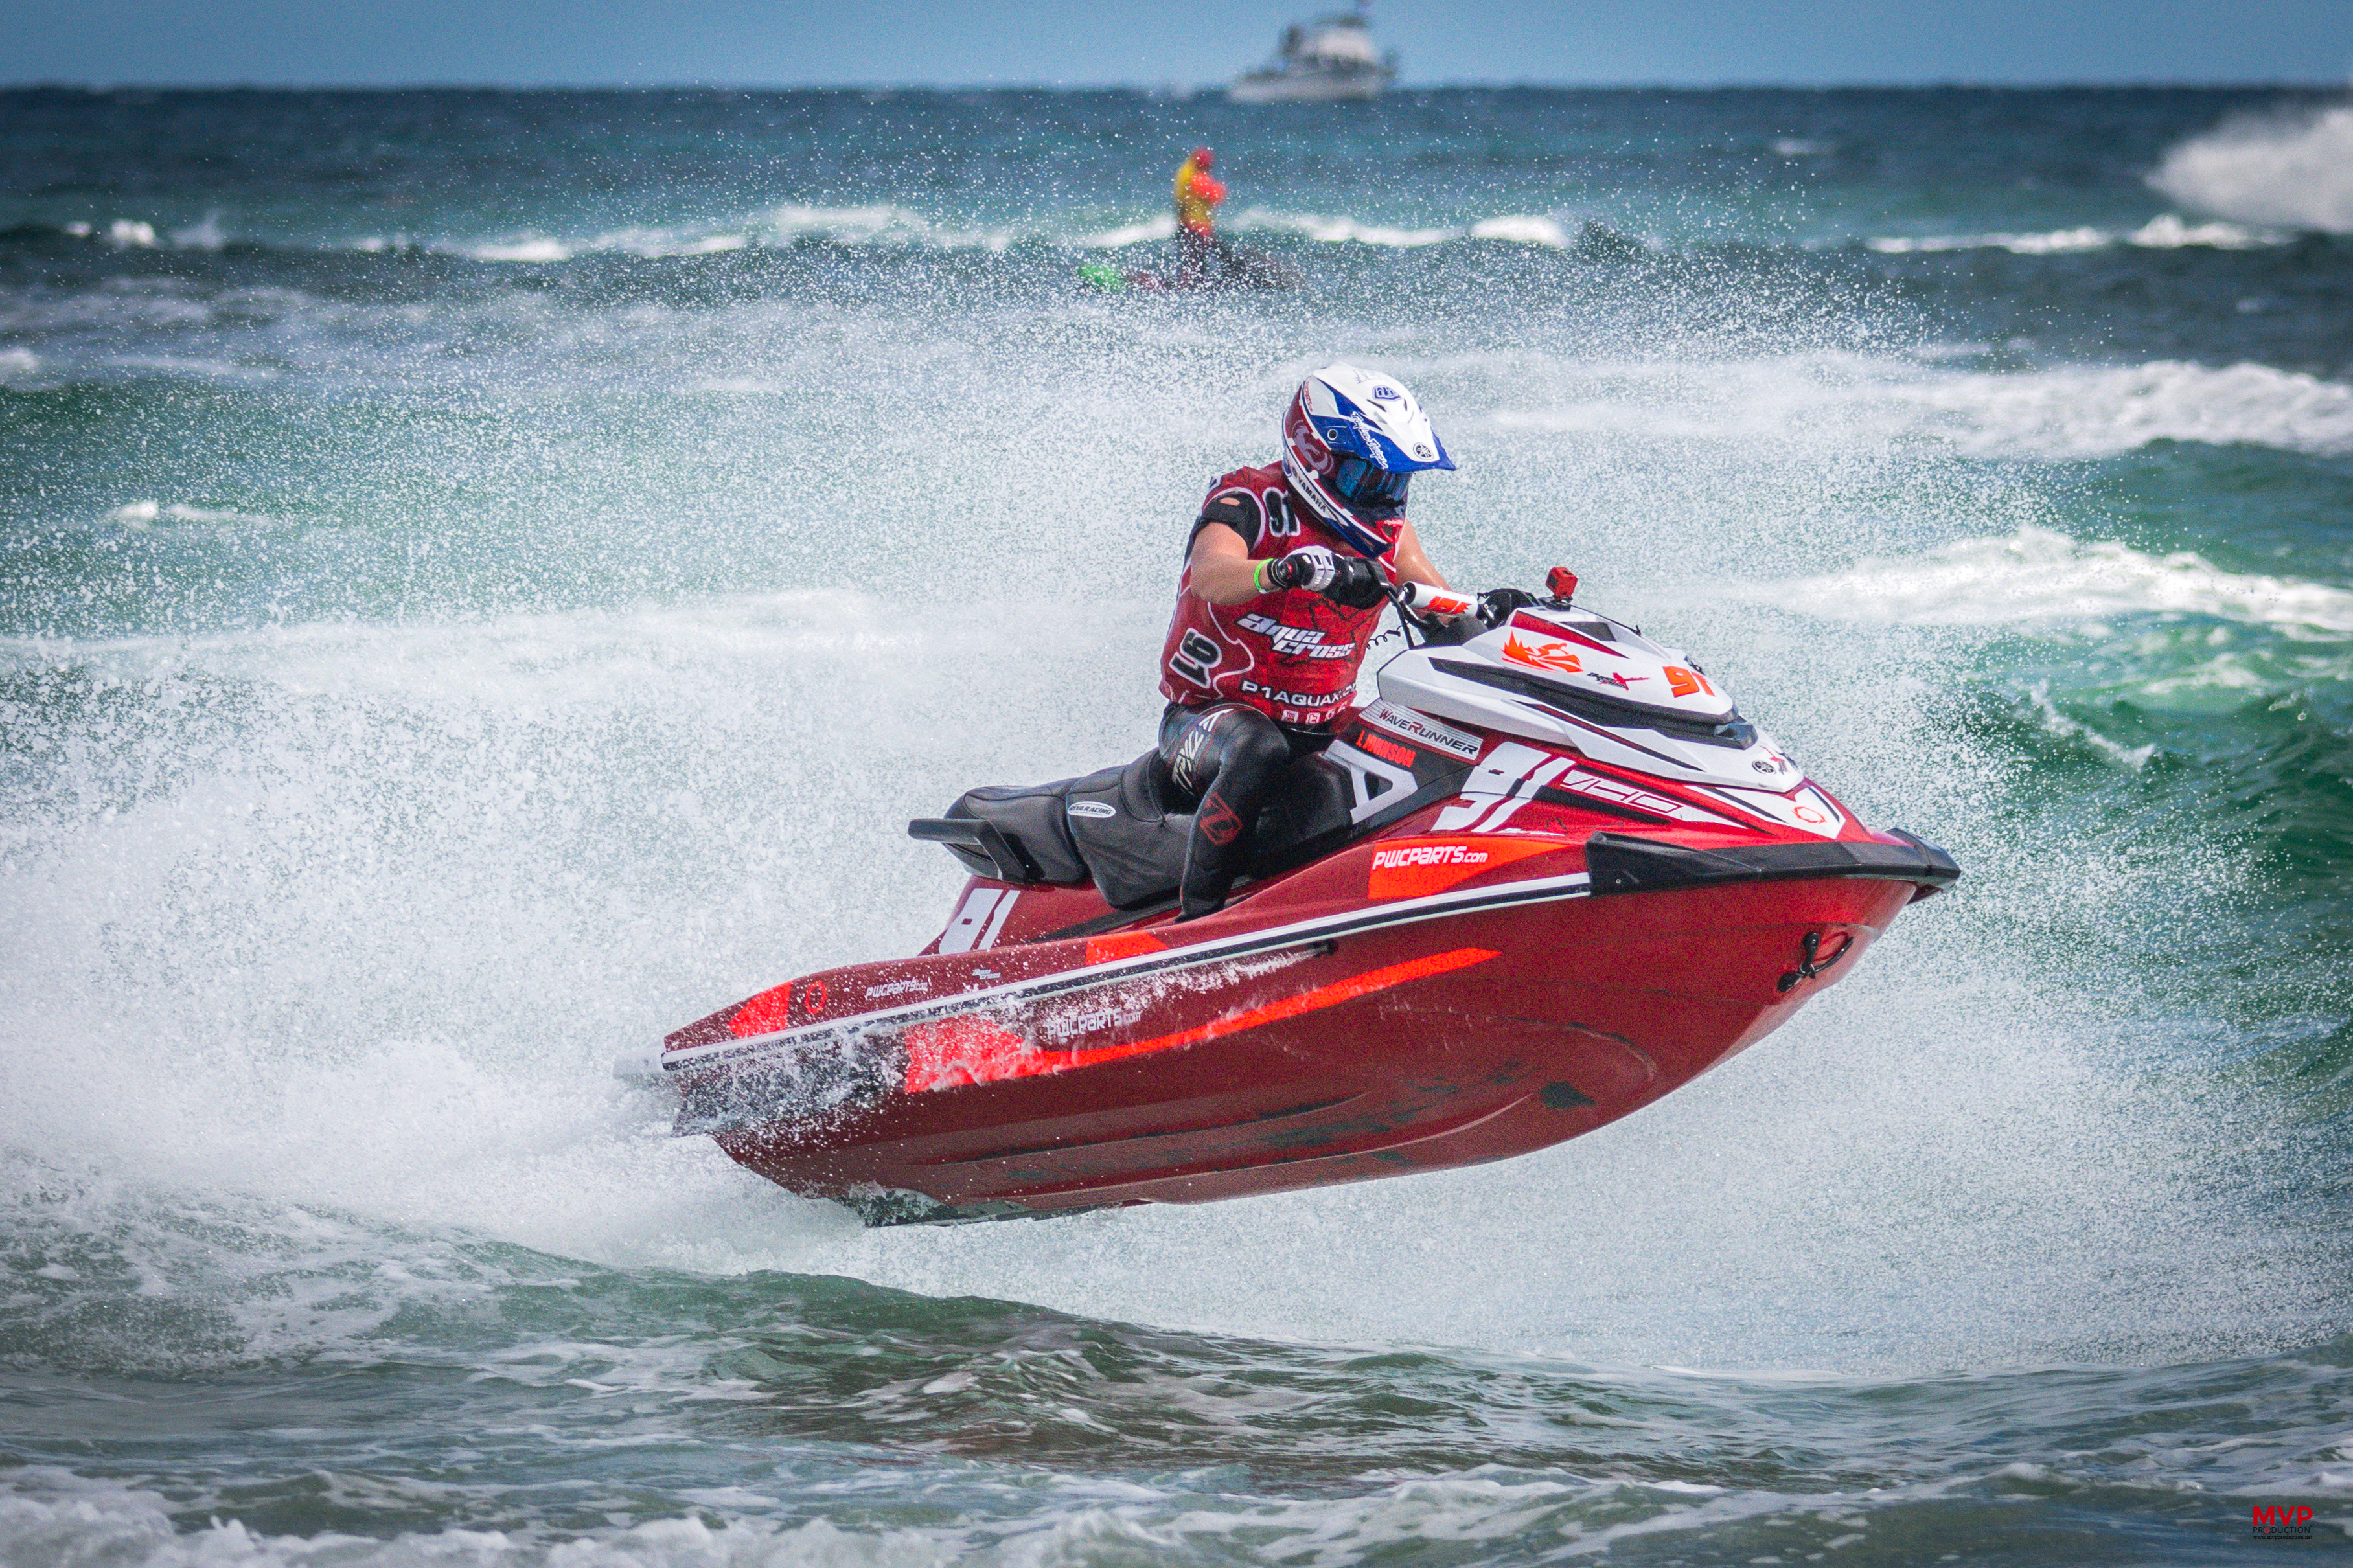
906;750;1348;910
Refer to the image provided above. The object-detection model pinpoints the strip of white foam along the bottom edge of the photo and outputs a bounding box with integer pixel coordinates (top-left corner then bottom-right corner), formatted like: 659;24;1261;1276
0;1476;1732;1568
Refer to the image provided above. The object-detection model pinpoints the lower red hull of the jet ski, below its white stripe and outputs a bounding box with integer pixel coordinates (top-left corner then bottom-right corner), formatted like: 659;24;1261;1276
678;860;1920;1222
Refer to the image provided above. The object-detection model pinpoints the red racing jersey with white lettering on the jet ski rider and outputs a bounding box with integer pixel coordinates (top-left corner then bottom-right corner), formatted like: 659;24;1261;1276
1160;463;1405;729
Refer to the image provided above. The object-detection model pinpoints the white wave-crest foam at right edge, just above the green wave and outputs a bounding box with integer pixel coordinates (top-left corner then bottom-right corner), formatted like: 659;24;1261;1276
1723;527;2353;637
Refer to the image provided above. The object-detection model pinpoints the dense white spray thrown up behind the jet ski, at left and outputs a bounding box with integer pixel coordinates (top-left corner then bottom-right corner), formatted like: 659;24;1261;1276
0;595;1155;1267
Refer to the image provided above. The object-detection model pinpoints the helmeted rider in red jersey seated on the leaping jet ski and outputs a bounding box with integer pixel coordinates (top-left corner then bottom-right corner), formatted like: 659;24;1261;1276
1160;364;1468;919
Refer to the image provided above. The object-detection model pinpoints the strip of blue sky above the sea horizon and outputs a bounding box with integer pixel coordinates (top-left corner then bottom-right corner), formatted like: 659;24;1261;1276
14;0;2353;87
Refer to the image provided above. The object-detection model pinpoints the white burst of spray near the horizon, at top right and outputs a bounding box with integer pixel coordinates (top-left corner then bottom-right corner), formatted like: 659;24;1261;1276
2148;106;2353;233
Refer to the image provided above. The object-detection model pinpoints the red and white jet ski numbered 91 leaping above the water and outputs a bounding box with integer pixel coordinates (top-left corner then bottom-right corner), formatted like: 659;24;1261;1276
623;571;1960;1225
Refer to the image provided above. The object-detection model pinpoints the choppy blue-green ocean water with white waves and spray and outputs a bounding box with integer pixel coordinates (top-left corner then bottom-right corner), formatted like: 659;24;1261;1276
0;89;2353;1568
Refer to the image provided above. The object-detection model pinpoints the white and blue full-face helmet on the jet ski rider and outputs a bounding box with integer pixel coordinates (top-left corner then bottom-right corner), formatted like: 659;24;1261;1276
1282;365;1454;557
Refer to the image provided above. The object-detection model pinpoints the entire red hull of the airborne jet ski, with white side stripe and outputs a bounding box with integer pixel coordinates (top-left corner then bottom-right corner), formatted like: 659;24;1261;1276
671;813;1934;1220
